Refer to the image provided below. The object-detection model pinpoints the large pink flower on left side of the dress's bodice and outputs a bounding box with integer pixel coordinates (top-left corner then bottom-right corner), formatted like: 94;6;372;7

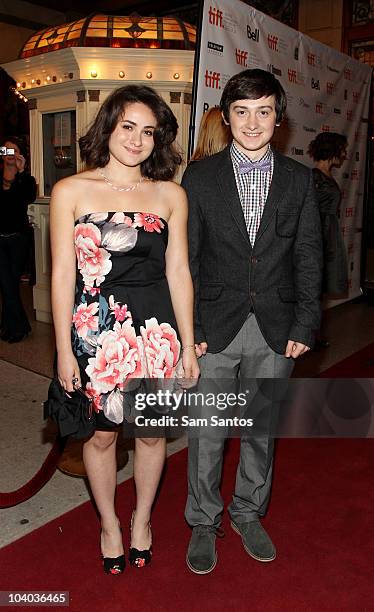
74;223;112;290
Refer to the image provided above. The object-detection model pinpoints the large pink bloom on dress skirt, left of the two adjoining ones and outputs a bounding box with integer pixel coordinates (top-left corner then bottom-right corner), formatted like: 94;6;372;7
86;319;142;393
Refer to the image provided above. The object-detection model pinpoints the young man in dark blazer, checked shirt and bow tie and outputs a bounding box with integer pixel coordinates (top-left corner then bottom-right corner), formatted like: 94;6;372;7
182;69;322;574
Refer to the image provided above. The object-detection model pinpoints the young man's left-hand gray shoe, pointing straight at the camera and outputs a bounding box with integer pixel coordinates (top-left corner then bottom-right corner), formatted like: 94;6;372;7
186;525;217;574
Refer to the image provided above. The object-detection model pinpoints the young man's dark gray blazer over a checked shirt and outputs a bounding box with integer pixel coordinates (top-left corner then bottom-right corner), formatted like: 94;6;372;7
182;146;322;353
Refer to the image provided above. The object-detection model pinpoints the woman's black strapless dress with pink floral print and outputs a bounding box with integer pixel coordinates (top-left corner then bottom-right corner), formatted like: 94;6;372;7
72;212;180;429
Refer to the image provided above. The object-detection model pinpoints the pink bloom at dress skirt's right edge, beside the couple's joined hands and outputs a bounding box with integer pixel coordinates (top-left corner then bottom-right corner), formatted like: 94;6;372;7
140;317;180;378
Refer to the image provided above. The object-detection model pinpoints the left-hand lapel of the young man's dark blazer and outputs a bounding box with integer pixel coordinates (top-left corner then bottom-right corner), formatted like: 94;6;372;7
217;145;252;249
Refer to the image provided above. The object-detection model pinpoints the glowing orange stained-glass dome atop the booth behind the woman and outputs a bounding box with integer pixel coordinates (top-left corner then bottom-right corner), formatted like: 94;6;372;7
19;15;196;58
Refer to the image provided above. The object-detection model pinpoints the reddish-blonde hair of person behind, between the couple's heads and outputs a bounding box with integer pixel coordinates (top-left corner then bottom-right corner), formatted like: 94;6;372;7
190;106;231;161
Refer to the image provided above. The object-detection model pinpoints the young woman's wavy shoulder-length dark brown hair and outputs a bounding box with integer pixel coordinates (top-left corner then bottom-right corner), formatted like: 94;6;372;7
79;85;182;181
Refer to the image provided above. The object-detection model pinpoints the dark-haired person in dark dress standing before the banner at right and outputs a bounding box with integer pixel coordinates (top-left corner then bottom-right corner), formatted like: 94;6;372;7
308;132;348;348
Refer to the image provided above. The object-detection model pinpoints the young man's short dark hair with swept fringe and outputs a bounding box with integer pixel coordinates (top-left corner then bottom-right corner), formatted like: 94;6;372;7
220;68;287;123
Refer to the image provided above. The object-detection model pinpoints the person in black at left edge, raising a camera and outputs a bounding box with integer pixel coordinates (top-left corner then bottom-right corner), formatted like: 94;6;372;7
0;138;36;343
